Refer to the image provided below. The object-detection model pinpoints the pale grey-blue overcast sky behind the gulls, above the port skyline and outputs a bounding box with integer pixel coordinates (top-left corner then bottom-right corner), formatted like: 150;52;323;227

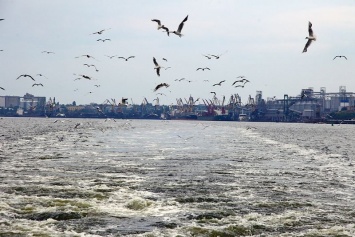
0;0;355;105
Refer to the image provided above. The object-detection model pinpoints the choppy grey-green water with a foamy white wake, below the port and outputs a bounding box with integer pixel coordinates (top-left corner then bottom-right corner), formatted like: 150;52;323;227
0;118;355;237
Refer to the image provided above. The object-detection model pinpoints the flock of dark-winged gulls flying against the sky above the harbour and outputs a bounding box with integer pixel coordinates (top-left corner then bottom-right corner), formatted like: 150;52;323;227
0;15;347;104
